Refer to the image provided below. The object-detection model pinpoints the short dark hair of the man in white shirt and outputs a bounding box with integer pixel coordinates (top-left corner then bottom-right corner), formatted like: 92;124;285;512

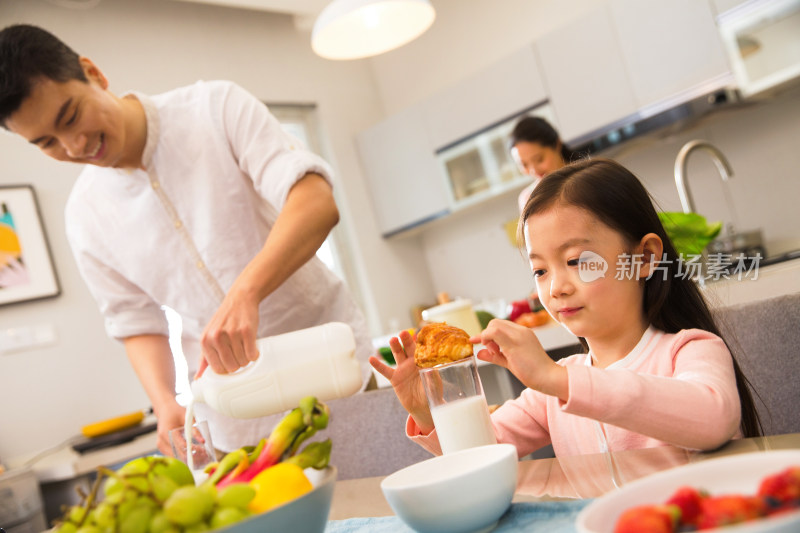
0;24;88;127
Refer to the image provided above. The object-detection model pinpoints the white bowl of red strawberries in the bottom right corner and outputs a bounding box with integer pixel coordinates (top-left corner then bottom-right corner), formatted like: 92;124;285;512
576;450;800;533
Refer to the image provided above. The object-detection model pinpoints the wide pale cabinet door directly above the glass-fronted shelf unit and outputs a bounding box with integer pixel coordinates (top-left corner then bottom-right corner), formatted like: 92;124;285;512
422;45;547;149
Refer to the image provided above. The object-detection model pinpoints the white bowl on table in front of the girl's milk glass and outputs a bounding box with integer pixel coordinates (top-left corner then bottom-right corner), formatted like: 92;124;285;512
381;444;517;533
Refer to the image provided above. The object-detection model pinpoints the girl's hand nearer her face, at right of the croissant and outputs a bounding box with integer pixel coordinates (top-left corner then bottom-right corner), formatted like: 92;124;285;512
470;319;569;401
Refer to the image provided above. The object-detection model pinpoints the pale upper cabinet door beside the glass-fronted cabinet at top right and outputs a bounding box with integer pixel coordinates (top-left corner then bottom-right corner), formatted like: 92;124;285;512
610;0;731;108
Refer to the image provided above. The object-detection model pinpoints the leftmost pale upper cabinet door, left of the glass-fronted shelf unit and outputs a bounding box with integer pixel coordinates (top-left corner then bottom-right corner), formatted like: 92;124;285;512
357;107;449;236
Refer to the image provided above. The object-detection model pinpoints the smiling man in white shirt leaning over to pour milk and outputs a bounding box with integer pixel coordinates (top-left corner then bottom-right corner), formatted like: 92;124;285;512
0;25;372;454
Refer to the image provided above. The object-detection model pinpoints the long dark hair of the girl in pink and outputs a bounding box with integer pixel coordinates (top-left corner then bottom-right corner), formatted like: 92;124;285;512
517;159;763;437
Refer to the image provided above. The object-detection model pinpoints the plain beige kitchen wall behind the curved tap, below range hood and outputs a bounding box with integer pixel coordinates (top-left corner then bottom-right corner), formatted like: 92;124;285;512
611;87;800;255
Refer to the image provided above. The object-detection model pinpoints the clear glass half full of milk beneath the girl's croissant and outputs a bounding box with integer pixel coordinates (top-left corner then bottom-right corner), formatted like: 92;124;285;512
419;356;497;453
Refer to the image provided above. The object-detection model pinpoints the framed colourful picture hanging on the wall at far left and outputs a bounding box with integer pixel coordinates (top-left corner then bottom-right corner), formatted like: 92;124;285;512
0;185;61;305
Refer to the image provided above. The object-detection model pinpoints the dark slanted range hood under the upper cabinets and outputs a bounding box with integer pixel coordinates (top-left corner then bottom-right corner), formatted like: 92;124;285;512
566;75;742;155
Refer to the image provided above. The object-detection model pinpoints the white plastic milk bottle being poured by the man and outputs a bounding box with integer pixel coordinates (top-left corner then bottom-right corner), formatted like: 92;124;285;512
192;322;362;418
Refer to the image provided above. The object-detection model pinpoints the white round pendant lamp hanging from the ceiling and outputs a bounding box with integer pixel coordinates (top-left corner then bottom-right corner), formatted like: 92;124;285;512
311;0;436;59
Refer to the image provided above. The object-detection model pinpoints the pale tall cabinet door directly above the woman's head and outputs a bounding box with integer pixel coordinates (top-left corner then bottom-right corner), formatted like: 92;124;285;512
536;7;637;143
